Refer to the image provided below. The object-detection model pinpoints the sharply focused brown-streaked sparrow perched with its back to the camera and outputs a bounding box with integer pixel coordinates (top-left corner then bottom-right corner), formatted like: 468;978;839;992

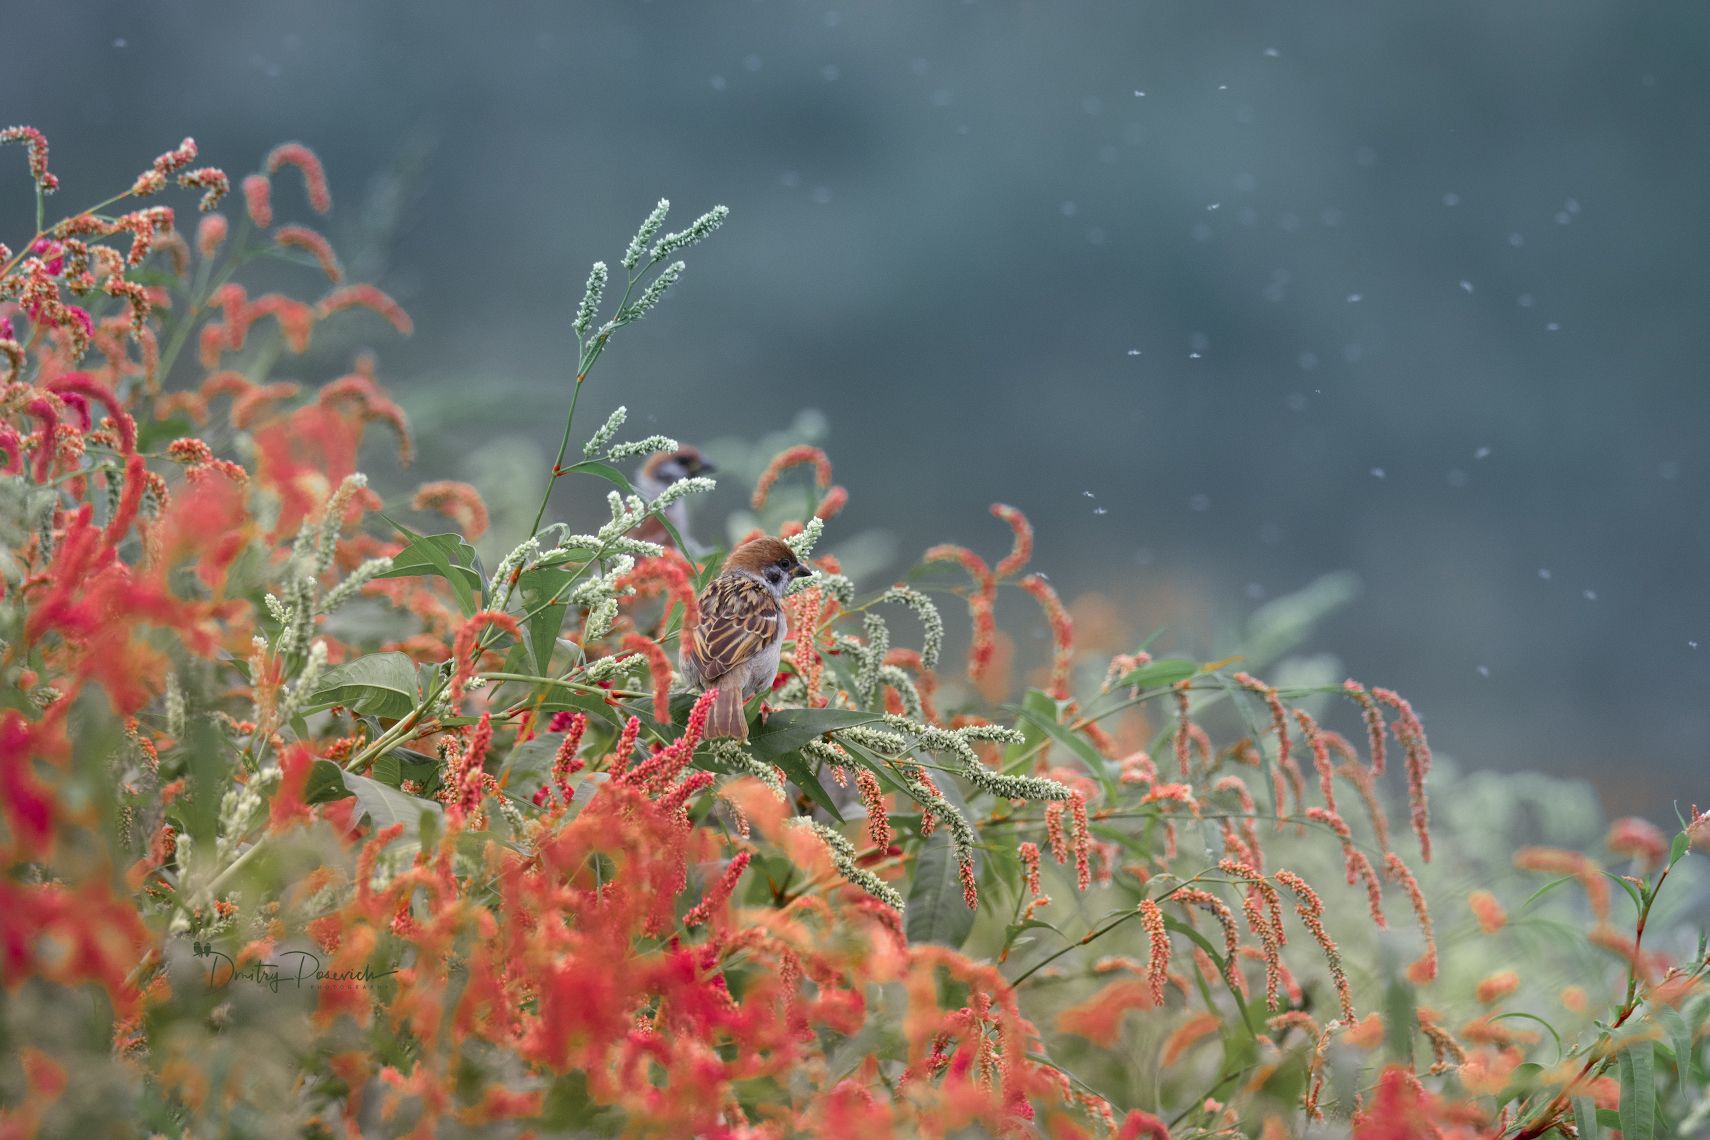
677;538;814;740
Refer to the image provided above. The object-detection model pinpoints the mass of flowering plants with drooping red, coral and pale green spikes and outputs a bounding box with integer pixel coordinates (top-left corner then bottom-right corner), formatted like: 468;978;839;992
0;128;1710;1137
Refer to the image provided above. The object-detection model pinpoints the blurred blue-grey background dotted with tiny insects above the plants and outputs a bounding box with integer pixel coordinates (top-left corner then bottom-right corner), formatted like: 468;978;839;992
13;0;1710;820
